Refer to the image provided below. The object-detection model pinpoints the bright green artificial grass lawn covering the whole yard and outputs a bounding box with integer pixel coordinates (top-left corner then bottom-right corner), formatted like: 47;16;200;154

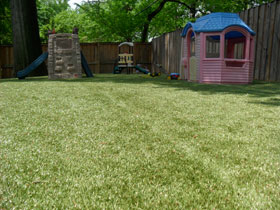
0;75;280;209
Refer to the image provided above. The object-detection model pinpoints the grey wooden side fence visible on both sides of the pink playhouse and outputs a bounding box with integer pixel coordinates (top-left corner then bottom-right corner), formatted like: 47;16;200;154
152;0;280;82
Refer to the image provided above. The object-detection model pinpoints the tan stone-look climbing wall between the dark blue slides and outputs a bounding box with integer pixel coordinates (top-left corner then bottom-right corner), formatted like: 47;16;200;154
48;34;82;79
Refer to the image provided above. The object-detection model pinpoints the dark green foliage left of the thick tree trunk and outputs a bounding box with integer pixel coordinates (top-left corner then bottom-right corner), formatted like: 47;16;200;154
0;0;12;44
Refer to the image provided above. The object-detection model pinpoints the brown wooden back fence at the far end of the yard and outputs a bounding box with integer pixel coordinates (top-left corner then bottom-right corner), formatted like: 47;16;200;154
0;43;152;78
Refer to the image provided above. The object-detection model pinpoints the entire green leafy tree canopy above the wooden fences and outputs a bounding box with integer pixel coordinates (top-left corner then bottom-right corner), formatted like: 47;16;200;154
0;0;272;44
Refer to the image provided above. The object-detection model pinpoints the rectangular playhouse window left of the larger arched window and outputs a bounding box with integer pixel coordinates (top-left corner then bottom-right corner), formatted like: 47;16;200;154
206;36;220;58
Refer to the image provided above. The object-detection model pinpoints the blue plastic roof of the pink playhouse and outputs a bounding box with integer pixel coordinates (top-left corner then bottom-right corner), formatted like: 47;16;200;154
182;12;256;37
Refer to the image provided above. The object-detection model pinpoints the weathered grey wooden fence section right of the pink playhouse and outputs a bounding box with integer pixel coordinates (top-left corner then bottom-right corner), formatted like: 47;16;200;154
239;1;280;81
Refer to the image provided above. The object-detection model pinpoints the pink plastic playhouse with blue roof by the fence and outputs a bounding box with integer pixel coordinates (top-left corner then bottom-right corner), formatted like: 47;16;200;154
181;13;255;84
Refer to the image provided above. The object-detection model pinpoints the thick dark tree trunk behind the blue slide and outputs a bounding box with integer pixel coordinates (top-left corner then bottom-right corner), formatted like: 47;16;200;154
10;0;47;76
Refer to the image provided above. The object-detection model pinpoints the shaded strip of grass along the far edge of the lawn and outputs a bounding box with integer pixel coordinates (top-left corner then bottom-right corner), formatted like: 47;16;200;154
0;74;280;106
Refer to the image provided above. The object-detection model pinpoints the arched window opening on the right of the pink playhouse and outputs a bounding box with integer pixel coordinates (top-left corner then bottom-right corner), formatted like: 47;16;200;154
225;31;246;59
